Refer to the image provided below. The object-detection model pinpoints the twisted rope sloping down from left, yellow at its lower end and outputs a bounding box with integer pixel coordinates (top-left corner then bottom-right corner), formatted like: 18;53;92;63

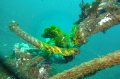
9;22;79;60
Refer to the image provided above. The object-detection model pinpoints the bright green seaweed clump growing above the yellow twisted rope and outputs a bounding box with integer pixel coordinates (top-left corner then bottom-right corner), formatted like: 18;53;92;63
41;25;70;48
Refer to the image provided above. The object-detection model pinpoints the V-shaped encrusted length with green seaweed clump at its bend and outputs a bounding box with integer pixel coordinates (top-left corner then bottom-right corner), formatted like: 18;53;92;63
9;0;120;59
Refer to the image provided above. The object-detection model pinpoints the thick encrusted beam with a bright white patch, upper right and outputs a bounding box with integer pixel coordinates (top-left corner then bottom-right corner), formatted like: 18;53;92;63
72;0;120;46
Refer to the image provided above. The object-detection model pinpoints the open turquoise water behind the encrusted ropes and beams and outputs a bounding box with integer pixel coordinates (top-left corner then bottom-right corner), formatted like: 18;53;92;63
0;0;120;79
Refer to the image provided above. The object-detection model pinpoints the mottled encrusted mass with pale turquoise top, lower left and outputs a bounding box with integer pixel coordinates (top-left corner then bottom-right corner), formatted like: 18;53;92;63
1;43;51;79
